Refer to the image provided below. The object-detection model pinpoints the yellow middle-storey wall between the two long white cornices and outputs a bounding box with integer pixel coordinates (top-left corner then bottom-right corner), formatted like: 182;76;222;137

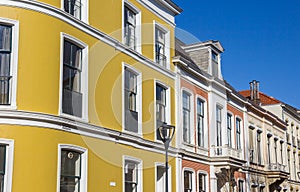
0;3;175;139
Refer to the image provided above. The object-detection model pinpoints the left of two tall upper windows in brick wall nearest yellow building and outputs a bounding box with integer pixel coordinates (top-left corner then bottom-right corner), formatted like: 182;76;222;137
182;91;191;143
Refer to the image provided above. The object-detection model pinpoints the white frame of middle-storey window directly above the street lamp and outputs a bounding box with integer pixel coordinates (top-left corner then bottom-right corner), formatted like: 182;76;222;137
153;80;171;141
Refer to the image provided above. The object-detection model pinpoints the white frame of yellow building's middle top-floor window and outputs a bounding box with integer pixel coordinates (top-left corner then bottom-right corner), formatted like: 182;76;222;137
122;0;142;53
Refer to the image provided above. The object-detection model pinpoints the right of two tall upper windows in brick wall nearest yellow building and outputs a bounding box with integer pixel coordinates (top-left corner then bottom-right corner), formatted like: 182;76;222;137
197;98;204;147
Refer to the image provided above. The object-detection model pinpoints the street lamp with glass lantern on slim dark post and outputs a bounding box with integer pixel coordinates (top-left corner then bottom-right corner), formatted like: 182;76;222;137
158;123;175;192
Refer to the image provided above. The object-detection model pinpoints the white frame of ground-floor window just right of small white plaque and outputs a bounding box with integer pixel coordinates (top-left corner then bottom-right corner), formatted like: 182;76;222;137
122;155;143;192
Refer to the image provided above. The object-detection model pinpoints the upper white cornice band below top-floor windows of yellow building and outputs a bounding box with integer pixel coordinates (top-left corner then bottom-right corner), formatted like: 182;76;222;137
0;0;175;79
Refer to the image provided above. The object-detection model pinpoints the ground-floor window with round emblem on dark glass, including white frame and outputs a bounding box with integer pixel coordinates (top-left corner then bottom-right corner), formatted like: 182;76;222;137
58;145;87;192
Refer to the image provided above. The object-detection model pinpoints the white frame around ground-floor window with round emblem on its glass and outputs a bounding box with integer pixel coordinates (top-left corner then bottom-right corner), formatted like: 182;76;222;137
56;144;88;192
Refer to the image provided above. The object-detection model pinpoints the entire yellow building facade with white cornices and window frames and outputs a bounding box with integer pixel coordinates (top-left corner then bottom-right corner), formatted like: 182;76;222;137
0;0;181;192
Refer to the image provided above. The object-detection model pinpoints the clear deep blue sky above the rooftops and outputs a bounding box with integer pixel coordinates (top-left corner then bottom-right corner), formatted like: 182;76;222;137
173;0;300;109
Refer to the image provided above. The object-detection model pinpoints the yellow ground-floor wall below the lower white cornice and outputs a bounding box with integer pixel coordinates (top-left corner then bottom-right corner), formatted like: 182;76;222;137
0;125;175;192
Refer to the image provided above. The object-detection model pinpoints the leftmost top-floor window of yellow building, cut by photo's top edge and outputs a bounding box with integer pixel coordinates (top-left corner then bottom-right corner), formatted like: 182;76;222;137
62;0;88;22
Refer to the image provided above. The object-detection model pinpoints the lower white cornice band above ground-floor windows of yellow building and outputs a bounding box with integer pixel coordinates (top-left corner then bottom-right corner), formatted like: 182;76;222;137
0;110;178;157
